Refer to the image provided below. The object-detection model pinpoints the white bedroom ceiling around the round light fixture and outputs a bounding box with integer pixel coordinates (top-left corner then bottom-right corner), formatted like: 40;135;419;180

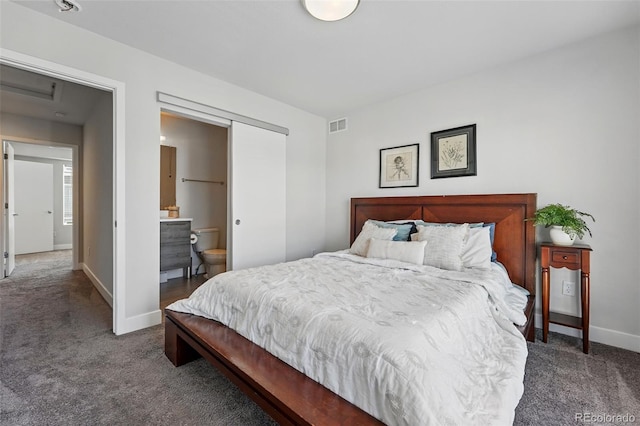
7;0;640;119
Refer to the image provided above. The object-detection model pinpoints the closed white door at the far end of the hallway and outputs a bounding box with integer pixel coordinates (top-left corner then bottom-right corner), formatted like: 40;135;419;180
14;160;53;254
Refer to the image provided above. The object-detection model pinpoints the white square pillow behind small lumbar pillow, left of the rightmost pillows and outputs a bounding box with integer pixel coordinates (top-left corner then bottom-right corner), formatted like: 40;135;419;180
415;223;469;271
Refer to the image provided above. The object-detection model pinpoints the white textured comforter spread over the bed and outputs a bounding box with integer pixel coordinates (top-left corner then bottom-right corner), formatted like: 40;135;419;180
167;252;527;425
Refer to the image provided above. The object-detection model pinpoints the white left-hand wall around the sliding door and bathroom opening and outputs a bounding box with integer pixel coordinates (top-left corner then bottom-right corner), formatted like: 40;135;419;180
0;2;326;330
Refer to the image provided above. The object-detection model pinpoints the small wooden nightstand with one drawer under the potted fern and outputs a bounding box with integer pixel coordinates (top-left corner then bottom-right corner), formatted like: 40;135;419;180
540;243;591;354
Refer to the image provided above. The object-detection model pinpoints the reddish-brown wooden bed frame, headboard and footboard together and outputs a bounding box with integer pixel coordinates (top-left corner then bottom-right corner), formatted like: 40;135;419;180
165;194;536;425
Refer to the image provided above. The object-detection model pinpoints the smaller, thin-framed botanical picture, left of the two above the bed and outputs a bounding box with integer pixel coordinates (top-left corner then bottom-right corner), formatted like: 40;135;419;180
380;143;420;188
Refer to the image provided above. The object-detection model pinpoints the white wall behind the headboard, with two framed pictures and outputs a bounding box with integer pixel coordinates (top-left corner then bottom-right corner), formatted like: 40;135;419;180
327;28;640;351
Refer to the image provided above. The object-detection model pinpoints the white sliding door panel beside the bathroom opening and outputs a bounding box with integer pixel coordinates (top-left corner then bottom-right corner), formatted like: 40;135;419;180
227;121;286;270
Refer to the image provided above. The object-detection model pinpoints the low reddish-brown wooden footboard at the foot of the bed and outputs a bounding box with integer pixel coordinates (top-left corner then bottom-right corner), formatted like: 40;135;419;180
165;310;382;425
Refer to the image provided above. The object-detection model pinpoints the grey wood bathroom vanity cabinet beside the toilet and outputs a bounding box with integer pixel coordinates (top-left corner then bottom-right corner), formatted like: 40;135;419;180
160;219;191;277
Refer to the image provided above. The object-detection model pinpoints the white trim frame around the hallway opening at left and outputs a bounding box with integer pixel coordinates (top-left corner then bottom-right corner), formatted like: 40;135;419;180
0;49;127;335
